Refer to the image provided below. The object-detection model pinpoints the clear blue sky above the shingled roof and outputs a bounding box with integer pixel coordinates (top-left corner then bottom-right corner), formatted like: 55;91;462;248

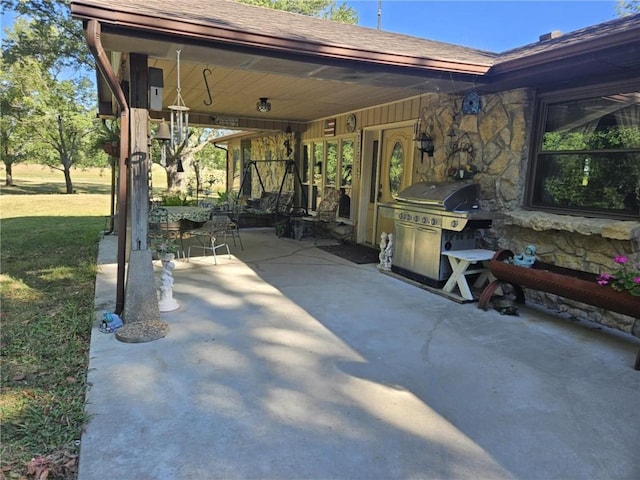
348;0;618;53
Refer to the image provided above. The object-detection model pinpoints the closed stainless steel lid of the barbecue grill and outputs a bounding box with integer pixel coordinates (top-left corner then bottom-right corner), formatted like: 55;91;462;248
396;182;480;211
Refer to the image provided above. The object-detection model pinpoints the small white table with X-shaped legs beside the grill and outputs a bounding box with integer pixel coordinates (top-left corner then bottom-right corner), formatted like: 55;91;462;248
441;249;496;300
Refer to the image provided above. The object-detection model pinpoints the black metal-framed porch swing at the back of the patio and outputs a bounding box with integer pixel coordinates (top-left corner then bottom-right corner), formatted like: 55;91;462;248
234;159;307;233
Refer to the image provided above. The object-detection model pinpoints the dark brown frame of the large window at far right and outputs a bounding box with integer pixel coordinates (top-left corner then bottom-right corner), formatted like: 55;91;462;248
524;80;640;221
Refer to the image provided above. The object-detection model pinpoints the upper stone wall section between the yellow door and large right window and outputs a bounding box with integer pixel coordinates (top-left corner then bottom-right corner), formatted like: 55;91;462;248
416;90;533;211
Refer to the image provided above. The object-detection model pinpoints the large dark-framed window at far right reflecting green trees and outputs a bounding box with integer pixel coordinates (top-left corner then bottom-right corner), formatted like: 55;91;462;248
527;85;640;219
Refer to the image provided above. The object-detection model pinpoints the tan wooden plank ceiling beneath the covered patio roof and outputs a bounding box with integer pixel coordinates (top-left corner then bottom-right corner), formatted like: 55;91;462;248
102;30;480;130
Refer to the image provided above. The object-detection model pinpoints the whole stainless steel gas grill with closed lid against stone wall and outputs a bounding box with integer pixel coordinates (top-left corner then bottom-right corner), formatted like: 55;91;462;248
381;182;492;288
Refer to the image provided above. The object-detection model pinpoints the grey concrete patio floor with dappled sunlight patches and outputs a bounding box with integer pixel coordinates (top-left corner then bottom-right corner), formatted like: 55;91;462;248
79;229;640;480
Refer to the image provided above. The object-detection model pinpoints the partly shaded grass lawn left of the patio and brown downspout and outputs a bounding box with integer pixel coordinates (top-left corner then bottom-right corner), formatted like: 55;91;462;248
0;165;111;480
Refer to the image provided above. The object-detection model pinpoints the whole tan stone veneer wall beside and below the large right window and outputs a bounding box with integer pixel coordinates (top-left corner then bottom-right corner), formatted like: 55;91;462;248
415;89;640;337
